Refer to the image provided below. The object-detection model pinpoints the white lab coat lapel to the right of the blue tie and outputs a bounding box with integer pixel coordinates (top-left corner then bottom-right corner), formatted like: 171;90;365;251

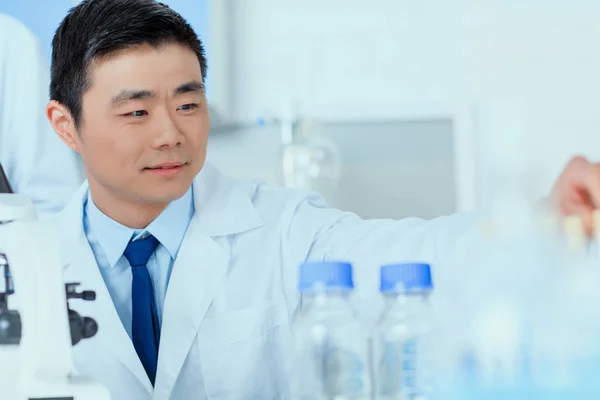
154;165;263;400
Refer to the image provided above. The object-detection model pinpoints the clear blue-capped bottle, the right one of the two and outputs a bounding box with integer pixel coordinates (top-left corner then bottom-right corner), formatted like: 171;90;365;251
373;263;433;400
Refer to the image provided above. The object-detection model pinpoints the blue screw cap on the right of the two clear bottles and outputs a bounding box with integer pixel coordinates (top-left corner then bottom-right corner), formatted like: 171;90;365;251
379;263;433;293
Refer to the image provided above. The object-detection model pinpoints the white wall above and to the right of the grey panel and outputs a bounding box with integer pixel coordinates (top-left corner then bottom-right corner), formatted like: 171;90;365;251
211;0;600;216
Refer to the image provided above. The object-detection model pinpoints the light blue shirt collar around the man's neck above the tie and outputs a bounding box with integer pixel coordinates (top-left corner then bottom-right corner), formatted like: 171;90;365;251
85;188;195;267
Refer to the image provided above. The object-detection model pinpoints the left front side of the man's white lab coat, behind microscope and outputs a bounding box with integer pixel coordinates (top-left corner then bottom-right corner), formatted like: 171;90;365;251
60;185;152;396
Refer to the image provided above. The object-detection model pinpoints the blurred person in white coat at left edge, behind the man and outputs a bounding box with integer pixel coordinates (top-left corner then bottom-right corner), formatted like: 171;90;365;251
0;14;83;216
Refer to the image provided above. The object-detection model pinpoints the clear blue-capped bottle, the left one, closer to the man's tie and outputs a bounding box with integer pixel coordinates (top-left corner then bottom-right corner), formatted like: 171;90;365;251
290;262;371;400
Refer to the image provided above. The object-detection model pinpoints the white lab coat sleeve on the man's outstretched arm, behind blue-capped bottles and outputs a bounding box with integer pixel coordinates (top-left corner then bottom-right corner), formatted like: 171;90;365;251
283;190;485;318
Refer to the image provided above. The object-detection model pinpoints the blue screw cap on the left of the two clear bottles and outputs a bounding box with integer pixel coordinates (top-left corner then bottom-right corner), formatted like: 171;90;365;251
298;261;354;292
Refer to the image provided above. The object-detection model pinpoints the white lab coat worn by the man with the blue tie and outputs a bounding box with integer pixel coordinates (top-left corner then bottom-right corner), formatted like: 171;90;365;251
58;165;476;400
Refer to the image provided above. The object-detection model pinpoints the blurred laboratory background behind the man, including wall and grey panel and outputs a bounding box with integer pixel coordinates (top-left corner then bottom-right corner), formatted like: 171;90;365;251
7;0;600;218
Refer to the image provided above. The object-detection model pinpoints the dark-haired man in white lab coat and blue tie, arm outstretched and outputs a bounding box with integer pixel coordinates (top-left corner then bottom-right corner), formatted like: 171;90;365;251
47;0;600;400
